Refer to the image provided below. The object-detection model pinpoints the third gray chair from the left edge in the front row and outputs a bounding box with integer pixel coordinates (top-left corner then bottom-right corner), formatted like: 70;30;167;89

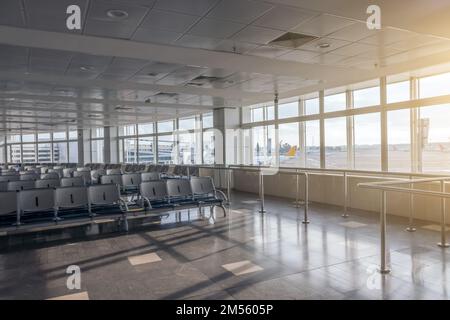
55;186;90;220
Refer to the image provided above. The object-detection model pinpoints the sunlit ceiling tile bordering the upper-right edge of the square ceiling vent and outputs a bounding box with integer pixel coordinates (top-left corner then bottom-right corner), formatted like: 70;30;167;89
292;14;355;37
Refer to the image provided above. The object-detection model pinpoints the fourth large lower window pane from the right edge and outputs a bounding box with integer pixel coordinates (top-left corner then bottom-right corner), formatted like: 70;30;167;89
325;117;347;169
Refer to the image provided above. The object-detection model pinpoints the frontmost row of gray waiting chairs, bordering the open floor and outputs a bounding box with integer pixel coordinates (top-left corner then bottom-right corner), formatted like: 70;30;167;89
0;177;227;225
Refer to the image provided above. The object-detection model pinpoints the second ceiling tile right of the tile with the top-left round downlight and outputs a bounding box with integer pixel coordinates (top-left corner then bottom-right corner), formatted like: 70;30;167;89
188;18;245;39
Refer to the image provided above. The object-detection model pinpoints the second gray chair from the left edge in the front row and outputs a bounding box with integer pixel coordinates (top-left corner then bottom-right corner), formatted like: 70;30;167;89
16;189;55;225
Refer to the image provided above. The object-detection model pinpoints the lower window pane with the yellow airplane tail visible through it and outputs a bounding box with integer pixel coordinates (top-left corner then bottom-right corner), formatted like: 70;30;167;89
278;123;300;167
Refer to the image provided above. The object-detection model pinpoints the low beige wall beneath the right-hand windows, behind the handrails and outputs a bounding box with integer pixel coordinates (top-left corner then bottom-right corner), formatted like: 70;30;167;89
232;170;450;223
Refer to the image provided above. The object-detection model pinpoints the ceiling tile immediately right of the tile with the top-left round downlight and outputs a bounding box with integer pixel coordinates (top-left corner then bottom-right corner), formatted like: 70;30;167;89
140;9;200;32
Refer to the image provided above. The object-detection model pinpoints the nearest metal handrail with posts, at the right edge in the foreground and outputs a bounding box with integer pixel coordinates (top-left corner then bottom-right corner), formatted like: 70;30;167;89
358;177;450;273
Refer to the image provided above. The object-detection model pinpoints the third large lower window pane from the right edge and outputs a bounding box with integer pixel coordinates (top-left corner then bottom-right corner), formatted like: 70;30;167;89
354;113;381;171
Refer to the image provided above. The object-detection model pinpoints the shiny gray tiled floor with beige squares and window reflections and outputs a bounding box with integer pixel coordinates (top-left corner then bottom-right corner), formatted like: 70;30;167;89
0;193;450;300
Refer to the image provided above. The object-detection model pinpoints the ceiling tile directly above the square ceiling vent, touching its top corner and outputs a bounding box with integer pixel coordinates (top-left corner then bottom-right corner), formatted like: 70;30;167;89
253;6;317;30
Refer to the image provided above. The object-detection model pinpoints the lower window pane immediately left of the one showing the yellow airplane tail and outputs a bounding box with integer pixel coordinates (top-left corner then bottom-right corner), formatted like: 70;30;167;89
252;125;275;165
